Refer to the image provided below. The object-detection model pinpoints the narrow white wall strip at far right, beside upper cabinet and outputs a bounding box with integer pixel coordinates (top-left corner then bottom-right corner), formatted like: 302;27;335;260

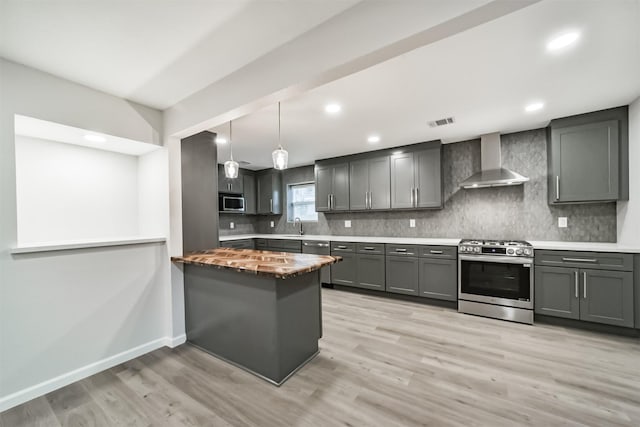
618;98;640;245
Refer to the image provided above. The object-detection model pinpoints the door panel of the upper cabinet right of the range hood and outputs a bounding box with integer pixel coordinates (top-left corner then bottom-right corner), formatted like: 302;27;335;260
549;120;619;203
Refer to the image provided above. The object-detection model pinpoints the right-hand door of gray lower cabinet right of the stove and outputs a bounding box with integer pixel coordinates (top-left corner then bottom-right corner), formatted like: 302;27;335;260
580;269;633;327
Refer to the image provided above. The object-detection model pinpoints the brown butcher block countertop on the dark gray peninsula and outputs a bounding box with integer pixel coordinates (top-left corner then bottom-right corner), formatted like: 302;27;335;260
171;248;342;279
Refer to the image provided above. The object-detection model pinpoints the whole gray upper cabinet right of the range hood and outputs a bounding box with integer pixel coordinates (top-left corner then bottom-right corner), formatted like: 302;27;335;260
547;107;629;204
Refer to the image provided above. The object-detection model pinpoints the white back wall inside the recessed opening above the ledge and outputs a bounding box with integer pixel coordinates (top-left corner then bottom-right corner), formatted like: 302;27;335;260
16;135;138;246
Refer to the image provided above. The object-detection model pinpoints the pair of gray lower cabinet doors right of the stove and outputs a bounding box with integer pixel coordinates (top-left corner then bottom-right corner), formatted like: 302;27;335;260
534;265;634;327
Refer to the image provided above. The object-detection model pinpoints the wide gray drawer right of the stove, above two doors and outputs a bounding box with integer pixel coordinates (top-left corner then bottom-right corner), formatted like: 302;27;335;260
535;250;633;271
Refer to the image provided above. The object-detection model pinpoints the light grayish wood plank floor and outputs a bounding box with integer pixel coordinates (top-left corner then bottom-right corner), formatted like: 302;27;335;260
0;289;640;427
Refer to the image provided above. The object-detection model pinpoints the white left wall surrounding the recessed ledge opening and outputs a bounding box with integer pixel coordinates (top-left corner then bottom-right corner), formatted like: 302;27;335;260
0;59;175;411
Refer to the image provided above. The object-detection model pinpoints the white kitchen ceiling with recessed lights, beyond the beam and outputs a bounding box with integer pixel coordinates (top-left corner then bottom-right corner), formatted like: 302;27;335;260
211;0;640;169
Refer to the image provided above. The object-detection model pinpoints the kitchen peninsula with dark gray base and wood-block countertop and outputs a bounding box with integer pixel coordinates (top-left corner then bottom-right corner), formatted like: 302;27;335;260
172;248;340;385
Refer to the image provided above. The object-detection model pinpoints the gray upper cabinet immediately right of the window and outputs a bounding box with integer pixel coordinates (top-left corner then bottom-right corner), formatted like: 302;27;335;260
315;163;349;212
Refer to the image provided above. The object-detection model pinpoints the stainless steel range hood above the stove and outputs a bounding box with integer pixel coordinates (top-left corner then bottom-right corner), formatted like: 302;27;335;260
460;132;529;189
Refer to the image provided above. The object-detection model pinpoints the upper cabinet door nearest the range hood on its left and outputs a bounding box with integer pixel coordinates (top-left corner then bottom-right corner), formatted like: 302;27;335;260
414;147;442;208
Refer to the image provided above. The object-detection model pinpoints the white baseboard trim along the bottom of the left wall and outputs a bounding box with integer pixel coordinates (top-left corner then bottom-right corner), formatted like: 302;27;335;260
0;334;187;412
